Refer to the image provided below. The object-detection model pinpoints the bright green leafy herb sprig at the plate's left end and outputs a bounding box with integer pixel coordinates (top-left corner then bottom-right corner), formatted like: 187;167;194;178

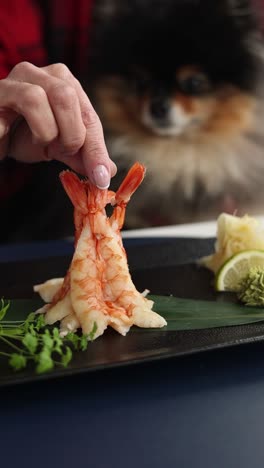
0;299;97;374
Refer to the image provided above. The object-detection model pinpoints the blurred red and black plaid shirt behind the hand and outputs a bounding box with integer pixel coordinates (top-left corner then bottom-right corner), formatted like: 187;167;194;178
0;0;92;201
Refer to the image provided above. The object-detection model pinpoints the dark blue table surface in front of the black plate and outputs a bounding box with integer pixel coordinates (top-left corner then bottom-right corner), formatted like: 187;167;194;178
0;239;264;468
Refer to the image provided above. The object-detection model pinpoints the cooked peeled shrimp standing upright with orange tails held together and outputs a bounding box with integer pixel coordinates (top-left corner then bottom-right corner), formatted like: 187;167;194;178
34;163;167;338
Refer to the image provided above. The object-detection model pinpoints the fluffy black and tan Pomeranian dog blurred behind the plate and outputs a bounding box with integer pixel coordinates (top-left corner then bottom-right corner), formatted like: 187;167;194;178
89;0;264;228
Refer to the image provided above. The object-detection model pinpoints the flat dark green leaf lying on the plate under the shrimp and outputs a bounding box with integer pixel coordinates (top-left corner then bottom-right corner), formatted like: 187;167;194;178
3;295;264;333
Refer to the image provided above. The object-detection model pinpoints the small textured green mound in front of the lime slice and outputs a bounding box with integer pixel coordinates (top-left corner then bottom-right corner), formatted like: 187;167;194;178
238;267;264;307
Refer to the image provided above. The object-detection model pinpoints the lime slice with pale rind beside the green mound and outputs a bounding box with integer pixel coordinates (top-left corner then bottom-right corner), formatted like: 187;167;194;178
215;250;264;291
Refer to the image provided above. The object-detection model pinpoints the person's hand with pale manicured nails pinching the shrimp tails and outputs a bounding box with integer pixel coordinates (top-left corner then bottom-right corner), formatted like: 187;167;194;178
0;62;116;188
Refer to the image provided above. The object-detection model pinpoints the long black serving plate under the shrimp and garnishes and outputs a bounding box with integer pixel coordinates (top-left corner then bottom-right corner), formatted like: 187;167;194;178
0;239;264;385
